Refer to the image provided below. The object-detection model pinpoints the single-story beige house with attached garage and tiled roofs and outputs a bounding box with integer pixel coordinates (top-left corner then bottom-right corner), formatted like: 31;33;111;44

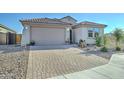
20;16;107;45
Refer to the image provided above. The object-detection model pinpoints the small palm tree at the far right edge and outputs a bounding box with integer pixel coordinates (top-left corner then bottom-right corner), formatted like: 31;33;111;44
113;28;123;50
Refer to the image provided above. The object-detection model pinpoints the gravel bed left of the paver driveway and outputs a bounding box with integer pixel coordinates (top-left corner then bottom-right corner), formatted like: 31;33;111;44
0;45;29;79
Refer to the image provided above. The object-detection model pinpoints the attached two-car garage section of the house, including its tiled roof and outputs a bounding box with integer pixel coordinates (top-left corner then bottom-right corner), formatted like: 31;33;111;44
20;18;71;45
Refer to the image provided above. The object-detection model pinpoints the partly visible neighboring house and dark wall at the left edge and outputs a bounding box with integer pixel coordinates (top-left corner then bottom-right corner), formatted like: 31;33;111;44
0;24;16;45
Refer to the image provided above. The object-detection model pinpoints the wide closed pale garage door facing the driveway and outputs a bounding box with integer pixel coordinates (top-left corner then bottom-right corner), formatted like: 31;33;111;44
31;28;65;45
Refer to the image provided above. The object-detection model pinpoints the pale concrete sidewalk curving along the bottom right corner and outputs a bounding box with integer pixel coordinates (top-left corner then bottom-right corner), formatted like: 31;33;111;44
52;53;124;79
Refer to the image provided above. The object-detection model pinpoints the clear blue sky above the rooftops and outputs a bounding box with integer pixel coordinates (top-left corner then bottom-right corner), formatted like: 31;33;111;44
0;13;124;33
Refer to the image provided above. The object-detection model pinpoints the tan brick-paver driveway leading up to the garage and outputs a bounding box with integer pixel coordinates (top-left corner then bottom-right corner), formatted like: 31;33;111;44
26;48;108;79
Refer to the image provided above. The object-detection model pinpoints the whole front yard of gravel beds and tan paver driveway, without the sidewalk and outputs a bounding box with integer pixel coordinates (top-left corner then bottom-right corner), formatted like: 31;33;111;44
0;45;123;79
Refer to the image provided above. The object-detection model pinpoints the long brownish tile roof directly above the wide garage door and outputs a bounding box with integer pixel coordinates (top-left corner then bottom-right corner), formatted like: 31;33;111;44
20;18;71;25
